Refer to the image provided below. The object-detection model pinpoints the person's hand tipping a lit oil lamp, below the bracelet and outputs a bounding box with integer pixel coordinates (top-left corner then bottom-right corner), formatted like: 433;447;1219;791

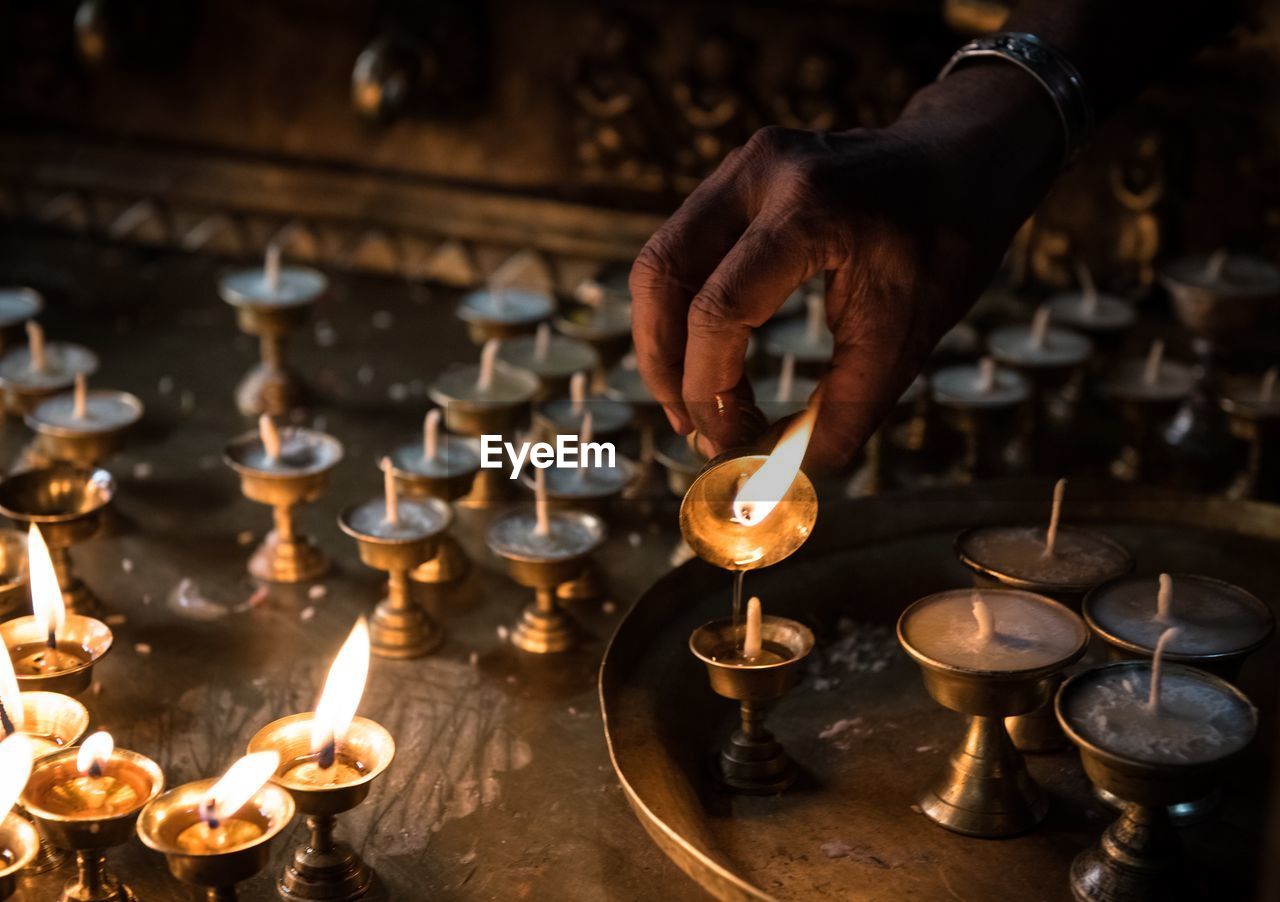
631;67;1061;467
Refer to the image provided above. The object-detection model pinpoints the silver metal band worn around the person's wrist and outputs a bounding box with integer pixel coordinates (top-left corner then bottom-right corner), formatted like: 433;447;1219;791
938;32;1093;165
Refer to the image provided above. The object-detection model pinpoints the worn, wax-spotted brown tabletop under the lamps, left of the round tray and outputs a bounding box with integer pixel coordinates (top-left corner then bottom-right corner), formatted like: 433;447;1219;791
0;233;701;902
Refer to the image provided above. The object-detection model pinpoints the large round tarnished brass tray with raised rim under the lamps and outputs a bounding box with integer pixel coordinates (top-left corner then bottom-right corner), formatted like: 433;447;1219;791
600;482;1280;902
